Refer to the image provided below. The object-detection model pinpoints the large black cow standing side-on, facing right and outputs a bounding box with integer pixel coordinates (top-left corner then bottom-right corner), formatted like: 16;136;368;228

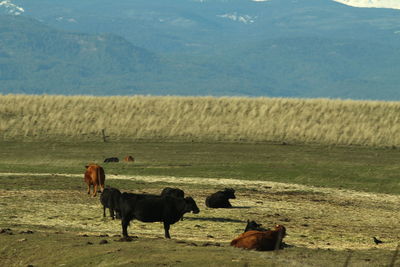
120;193;200;238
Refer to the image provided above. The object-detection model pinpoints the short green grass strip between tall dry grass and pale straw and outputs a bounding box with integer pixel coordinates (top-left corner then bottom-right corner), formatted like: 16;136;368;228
0;141;400;194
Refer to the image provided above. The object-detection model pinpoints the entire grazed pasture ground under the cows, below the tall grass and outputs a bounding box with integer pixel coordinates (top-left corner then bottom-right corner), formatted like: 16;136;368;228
0;142;400;266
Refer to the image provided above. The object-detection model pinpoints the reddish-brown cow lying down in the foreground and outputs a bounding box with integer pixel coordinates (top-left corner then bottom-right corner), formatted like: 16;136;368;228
231;225;286;251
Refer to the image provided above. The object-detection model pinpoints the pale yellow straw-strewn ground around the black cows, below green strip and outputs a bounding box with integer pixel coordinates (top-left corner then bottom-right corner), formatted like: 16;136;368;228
0;174;400;250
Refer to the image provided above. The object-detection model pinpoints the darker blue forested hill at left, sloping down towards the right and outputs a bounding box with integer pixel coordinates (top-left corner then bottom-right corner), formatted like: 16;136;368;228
0;16;160;94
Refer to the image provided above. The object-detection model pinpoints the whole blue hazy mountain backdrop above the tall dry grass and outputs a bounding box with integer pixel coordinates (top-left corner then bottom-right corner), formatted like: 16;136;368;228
0;0;400;100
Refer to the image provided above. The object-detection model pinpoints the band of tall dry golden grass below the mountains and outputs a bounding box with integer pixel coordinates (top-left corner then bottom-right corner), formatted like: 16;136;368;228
0;95;400;146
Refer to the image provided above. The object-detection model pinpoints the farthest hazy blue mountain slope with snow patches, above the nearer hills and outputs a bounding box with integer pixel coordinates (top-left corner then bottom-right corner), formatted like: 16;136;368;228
13;0;400;53
